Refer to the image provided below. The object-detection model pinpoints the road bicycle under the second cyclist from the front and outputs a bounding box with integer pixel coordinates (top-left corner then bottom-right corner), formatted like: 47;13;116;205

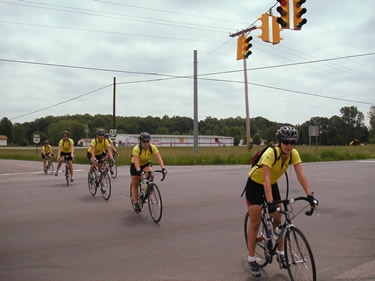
130;170;165;223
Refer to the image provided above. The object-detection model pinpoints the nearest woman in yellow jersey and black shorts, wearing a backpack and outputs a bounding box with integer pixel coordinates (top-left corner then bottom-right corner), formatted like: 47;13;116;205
246;126;317;277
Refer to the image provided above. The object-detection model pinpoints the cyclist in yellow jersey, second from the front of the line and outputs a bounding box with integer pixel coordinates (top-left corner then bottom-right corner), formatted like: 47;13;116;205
130;132;167;213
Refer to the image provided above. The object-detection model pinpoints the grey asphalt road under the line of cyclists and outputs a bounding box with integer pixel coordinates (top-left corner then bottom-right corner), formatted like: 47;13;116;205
0;160;375;281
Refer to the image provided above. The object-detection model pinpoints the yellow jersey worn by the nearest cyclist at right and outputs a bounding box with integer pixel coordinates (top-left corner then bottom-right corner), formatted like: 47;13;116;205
248;147;302;184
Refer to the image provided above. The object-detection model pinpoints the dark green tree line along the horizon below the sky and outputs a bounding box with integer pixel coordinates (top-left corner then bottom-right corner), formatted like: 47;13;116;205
0;106;375;146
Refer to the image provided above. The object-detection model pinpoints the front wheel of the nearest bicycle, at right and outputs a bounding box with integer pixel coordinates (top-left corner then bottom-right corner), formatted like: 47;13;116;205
284;226;316;281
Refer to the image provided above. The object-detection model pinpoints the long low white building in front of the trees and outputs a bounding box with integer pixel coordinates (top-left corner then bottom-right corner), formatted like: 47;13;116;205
114;134;234;147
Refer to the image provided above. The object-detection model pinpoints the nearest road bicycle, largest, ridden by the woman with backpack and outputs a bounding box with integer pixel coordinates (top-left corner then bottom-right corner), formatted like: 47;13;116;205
244;197;317;281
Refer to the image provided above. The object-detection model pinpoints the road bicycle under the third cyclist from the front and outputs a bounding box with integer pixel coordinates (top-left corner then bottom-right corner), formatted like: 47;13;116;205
88;160;112;201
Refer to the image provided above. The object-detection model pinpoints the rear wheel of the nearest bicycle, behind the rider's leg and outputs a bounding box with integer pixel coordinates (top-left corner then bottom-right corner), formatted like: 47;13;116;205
244;212;268;267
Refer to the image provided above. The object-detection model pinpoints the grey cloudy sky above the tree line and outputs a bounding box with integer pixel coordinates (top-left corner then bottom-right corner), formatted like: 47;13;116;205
0;0;375;124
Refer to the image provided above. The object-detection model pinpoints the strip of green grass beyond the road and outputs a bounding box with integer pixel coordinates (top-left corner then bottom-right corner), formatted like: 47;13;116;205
0;145;375;166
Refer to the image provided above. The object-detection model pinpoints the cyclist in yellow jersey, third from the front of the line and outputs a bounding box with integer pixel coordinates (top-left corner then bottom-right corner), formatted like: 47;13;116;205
87;129;113;177
